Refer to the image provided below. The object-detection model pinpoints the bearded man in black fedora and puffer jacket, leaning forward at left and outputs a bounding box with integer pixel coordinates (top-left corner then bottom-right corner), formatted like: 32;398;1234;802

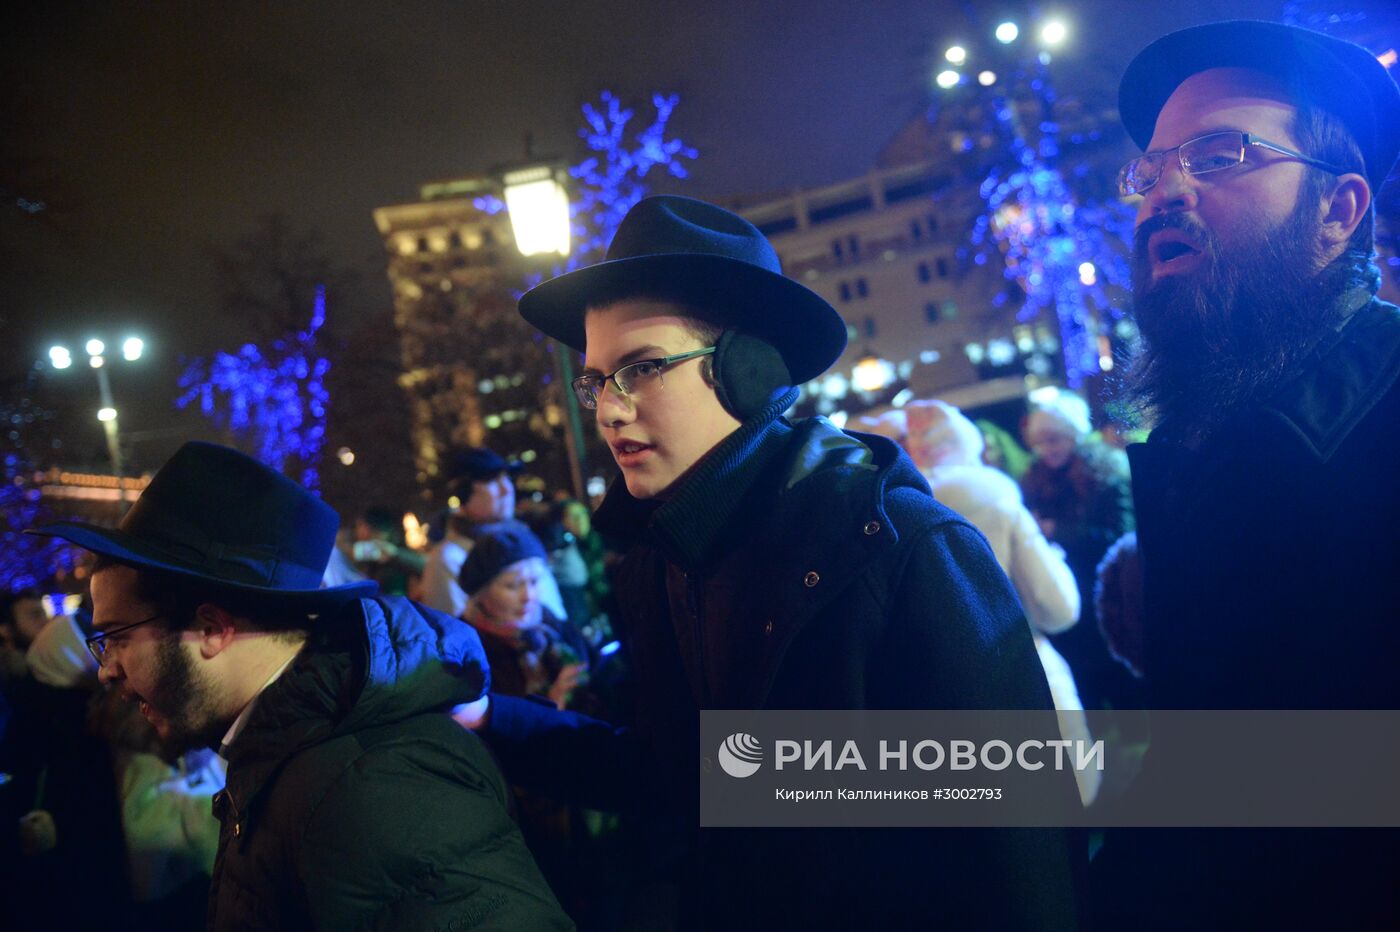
32;444;573;931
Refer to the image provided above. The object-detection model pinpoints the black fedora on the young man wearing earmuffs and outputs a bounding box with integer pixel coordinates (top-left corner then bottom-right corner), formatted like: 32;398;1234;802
519;195;846;382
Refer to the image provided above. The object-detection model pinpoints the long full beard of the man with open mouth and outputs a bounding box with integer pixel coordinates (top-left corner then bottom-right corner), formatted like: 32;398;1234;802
1126;197;1341;437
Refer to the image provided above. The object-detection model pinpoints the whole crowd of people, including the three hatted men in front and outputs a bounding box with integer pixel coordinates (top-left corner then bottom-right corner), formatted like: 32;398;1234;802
0;16;1400;931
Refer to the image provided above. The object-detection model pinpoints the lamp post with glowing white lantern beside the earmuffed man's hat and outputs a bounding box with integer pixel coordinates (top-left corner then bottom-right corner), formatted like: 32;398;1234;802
501;162;587;501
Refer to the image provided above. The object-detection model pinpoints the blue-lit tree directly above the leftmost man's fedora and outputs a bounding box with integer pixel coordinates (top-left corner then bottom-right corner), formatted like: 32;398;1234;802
175;285;330;488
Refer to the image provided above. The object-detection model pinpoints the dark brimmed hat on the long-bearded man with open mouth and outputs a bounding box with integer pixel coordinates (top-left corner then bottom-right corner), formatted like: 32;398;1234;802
1119;20;1400;190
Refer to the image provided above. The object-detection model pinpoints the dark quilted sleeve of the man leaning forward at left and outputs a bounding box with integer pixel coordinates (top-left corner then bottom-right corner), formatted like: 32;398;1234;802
295;715;574;932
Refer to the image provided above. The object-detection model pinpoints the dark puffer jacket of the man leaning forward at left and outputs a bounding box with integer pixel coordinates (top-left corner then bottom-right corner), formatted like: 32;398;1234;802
209;598;573;932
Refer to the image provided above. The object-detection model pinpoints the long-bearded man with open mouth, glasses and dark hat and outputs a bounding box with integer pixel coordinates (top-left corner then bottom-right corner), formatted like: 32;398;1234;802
1096;21;1400;929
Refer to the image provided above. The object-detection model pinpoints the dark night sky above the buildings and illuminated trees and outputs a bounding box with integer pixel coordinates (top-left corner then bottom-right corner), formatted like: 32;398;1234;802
0;0;1355;469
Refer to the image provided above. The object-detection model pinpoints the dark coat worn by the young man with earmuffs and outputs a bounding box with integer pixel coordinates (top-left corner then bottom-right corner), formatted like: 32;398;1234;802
487;411;1082;929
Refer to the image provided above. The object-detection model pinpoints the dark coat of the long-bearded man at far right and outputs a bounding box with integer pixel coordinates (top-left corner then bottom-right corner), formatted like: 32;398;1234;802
1103;293;1400;928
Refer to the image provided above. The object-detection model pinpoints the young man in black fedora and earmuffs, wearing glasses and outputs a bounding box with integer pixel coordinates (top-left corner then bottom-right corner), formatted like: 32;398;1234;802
464;196;1078;929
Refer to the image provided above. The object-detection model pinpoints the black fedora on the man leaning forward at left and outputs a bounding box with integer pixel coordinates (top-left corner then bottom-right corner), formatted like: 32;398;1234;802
28;442;378;601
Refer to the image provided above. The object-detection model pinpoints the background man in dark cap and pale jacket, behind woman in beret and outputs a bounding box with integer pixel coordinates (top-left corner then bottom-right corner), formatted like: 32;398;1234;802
423;446;567;619
